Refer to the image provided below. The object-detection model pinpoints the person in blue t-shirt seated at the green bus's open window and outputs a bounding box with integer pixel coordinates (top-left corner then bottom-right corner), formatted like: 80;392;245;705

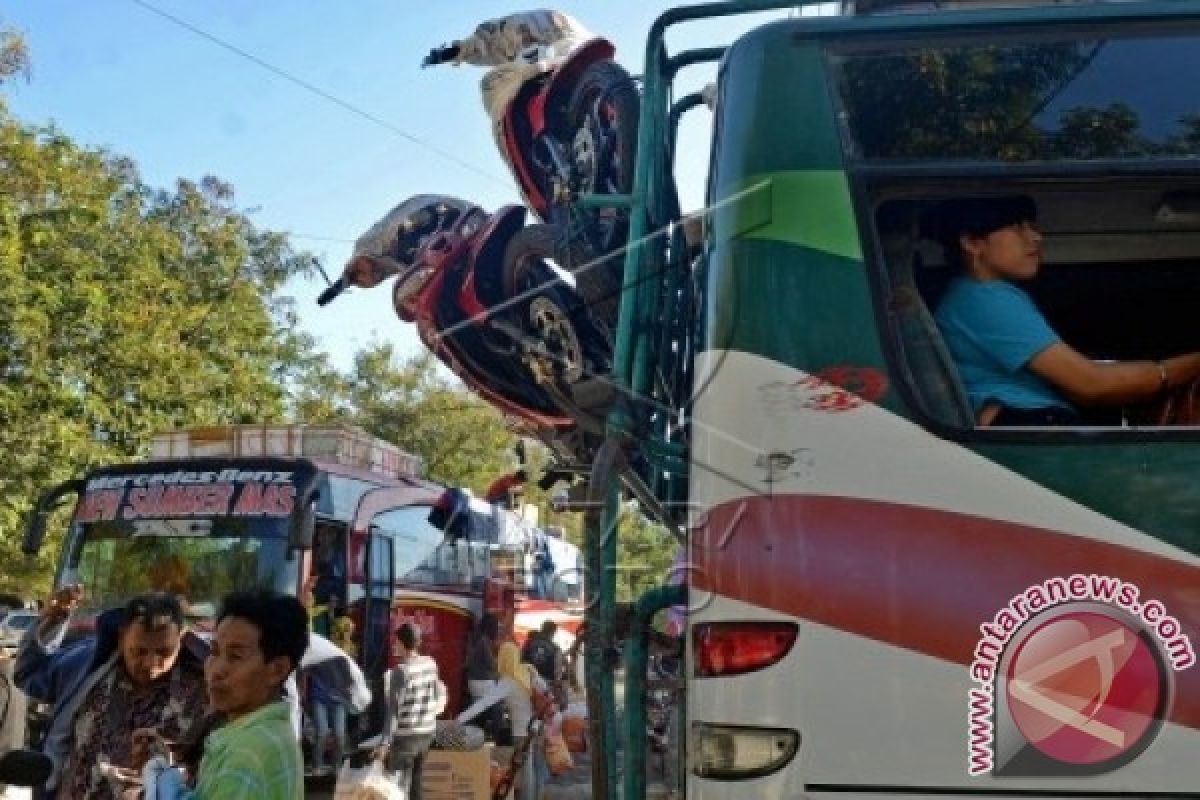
935;196;1200;426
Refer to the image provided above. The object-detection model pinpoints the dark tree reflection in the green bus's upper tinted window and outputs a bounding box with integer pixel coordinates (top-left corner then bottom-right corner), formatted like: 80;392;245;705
839;40;1200;161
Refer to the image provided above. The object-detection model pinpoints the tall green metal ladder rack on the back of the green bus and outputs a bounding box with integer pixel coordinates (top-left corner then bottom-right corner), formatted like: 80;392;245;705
581;0;840;800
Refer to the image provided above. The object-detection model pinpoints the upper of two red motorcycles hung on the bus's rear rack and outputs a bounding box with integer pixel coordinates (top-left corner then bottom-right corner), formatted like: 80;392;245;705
422;11;641;326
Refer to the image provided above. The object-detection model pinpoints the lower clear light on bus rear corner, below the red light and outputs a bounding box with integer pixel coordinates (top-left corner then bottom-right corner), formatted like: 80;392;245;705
691;722;800;781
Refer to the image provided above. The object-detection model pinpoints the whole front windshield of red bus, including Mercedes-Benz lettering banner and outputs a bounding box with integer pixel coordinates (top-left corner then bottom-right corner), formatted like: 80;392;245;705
56;458;313;620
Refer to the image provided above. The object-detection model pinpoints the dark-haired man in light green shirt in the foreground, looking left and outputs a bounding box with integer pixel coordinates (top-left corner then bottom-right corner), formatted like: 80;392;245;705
193;591;308;800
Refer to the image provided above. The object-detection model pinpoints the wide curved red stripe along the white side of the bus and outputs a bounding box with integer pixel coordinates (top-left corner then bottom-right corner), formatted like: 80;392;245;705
690;495;1200;728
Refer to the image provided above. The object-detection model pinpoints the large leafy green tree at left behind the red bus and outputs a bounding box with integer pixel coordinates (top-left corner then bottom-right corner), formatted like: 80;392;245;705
0;108;312;591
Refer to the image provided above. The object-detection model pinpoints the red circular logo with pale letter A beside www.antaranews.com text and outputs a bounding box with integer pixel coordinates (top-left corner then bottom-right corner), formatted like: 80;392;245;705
1004;612;1168;765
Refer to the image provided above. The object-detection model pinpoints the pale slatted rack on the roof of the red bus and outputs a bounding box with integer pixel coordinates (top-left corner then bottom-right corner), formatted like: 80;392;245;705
150;425;421;480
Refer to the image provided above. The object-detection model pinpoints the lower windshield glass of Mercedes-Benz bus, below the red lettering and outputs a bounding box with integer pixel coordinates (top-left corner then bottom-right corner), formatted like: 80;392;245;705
56;518;296;620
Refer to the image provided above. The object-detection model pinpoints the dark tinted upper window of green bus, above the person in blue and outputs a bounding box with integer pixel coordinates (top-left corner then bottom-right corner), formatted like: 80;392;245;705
830;28;1200;162
